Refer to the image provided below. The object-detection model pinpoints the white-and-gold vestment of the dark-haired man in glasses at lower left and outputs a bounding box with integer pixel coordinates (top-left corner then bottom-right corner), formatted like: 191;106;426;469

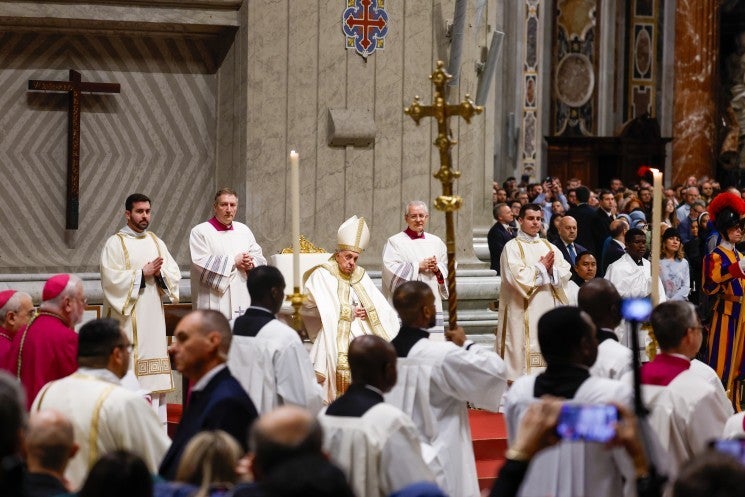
31;368;171;490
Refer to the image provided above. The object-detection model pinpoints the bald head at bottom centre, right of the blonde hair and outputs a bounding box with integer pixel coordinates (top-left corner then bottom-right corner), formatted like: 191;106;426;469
248;405;323;480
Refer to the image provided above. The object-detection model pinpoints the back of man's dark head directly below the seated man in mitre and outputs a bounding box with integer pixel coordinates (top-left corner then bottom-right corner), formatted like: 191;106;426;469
348;335;396;392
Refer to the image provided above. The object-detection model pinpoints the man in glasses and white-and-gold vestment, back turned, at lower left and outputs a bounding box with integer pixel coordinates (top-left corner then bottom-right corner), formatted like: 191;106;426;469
31;319;171;489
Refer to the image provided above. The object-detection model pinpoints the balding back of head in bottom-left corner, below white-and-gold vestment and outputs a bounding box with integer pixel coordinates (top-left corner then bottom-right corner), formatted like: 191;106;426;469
26;410;77;474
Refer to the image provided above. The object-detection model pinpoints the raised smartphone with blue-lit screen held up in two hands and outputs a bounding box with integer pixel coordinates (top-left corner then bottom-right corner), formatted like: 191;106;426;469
556;404;618;442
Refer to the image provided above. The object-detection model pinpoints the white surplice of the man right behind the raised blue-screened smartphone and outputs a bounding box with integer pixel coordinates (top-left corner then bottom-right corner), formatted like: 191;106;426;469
505;375;636;497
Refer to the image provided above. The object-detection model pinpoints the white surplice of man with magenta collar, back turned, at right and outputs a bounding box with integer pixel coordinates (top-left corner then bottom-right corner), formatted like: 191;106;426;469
629;369;731;469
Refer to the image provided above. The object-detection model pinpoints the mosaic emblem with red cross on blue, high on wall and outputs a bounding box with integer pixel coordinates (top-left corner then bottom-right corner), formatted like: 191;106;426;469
341;0;388;58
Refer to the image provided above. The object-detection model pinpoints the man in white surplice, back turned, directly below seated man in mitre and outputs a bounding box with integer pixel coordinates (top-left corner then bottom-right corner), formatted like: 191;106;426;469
319;335;435;497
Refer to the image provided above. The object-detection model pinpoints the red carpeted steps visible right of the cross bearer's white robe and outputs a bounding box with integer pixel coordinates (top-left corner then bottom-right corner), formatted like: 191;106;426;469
468;409;507;490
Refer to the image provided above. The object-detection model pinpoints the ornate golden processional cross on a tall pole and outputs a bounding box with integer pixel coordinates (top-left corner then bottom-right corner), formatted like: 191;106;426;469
404;60;484;330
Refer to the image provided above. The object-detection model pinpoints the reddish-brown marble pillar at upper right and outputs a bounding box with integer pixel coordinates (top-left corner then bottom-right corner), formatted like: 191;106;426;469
671;0;719;184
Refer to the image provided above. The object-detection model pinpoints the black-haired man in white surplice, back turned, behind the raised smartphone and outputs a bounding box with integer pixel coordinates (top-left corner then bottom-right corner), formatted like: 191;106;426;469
505;307;635;497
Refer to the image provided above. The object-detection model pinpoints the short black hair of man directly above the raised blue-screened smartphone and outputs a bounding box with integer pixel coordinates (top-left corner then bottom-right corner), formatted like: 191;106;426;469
538;305;592;364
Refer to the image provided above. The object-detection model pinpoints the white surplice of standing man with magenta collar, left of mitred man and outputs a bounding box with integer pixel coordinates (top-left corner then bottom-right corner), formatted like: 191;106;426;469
189;221;266;320
